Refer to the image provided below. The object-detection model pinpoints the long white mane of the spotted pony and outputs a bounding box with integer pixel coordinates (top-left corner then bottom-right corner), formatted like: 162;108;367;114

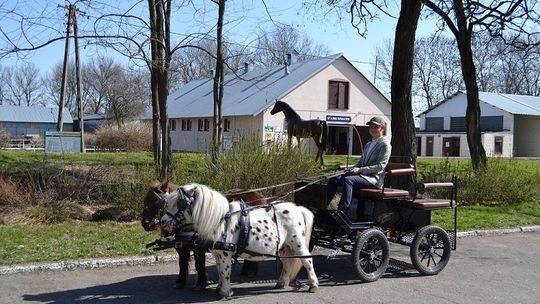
190;184;229;240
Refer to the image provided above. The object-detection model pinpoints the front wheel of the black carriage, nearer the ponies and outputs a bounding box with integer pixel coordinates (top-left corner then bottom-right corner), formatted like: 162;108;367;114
352;229;390;282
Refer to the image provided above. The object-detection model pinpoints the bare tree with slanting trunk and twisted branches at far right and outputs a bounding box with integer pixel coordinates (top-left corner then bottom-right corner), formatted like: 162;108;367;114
423;0;540;171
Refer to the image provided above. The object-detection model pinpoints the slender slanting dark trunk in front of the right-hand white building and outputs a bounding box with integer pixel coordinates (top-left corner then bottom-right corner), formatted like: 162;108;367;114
454;0;487;171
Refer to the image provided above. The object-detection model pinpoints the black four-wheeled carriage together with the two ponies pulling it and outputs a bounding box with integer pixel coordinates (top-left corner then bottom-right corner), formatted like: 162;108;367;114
142;162;457;297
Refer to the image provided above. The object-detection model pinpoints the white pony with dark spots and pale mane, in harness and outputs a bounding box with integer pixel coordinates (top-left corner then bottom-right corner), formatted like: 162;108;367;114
161;184;319;297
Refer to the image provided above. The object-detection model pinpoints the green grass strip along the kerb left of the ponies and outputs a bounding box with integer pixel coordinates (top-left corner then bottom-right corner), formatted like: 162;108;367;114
0;222;157;265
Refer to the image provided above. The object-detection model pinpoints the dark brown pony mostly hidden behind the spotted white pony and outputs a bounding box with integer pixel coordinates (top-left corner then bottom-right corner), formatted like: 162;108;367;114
141;181;266;288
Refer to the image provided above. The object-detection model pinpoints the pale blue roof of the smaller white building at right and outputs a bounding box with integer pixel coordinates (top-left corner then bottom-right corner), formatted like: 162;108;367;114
417;91;540;116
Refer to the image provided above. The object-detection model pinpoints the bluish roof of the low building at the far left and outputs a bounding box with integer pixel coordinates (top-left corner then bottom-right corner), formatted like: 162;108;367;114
0;105;73;123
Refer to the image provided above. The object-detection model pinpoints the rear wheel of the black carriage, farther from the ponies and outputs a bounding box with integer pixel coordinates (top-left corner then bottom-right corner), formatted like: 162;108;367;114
411;226;451;275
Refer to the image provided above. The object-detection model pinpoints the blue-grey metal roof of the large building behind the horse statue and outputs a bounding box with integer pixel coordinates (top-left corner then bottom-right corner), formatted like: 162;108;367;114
167;54;342;118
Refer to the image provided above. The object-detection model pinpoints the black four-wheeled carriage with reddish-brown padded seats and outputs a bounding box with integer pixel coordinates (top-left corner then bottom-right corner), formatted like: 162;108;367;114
294;162;457;282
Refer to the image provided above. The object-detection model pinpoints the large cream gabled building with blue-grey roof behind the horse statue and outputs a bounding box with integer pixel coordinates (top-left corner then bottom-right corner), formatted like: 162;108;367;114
167;54;391;154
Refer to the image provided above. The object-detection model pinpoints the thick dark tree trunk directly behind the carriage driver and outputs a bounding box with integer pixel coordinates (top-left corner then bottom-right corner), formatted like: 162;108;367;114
391;0;422;162
